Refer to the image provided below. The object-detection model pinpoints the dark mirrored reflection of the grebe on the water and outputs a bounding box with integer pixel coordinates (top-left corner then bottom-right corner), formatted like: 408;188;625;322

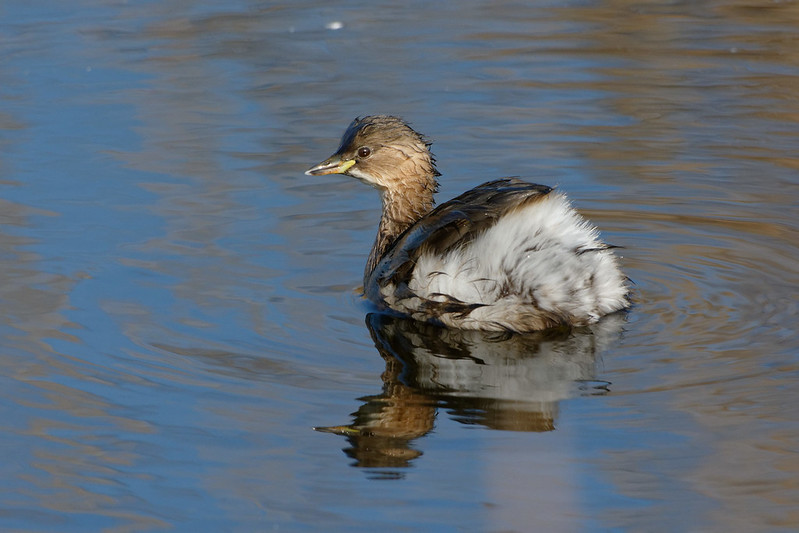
314;313;623;468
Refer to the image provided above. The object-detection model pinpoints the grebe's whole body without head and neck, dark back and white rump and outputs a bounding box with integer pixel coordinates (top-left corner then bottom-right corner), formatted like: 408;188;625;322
364;178;628;331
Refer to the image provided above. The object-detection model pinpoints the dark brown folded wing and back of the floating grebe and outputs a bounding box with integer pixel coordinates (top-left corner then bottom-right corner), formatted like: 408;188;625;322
365;178;552;304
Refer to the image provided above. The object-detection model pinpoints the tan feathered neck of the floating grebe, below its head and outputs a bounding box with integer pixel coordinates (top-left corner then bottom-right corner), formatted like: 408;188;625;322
364;183;437;280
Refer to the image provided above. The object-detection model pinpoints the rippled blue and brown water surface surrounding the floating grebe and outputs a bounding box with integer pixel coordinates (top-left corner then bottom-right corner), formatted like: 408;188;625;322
0;0;799;531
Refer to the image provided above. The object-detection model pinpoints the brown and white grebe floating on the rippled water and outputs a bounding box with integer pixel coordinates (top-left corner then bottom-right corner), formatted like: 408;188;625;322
305;115;631;333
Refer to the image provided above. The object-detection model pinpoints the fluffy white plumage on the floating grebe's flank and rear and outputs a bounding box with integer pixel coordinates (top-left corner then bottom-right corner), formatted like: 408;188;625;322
380;192;628;331
